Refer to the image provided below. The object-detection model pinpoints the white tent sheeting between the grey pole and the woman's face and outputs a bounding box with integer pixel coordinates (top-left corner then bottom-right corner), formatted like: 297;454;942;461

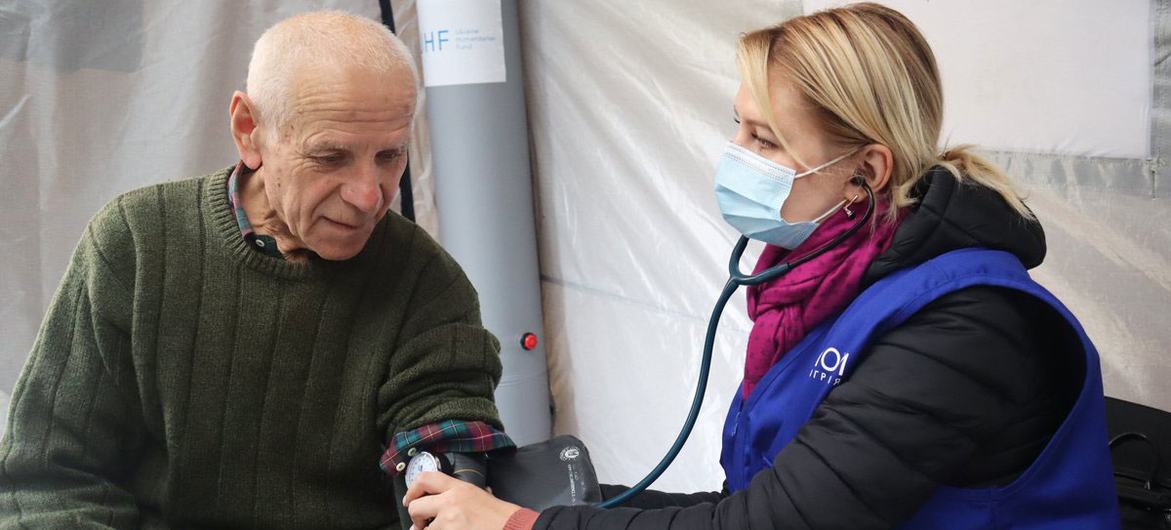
521;0;800;490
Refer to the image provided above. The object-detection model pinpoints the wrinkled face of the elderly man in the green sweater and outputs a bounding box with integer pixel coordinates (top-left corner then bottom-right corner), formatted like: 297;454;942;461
260;68;416;260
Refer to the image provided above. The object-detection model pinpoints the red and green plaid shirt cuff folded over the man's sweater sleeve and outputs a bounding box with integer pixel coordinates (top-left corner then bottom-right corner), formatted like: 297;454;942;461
378;420;516;476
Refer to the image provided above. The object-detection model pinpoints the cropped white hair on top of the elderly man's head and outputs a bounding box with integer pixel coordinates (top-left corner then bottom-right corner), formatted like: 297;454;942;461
245;11;418;132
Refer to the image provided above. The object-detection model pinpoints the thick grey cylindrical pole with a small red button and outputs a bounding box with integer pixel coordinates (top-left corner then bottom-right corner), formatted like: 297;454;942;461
417;0;552;445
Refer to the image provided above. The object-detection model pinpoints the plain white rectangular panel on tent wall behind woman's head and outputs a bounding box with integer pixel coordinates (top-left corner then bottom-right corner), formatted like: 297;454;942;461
804;0;1151;158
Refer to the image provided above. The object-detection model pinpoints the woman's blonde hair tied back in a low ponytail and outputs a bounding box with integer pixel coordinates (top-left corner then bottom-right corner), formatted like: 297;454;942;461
737;2;1033;220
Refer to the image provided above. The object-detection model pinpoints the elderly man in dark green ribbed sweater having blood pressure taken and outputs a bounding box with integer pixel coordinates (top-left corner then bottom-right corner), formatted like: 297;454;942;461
0;12;512;529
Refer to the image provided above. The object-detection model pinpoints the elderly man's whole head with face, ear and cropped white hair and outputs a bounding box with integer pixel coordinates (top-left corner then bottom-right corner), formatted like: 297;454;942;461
228;12;418;260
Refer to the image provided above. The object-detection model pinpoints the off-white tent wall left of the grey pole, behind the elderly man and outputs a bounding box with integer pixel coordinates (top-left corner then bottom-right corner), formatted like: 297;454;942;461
0;0;437;433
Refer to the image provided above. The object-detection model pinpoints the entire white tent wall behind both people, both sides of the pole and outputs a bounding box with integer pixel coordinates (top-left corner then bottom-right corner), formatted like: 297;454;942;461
0;0;1171;500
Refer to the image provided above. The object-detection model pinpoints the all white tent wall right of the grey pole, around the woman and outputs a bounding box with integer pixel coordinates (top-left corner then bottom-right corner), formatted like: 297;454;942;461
521;0;1171;490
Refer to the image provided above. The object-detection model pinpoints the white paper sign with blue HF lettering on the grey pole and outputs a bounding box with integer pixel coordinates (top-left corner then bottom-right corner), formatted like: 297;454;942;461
417;0;507;87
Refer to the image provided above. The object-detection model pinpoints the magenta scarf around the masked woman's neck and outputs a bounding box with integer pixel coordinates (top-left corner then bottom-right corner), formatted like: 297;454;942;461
740;204;902;399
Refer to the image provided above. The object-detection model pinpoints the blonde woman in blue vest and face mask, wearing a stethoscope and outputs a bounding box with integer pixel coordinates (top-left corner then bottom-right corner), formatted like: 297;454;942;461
406;4;1119;530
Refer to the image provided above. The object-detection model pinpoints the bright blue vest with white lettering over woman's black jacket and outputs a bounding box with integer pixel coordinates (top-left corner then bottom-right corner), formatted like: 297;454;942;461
720;249;1119;530
